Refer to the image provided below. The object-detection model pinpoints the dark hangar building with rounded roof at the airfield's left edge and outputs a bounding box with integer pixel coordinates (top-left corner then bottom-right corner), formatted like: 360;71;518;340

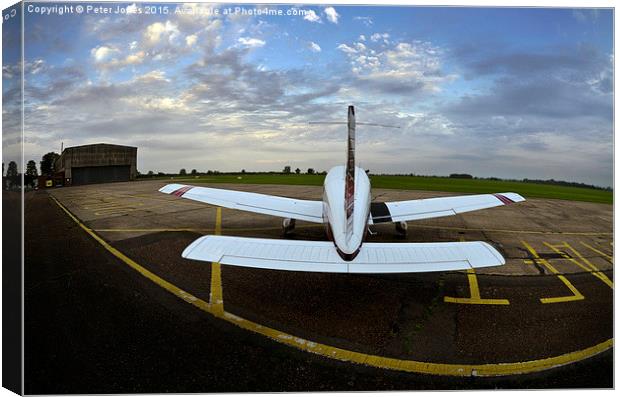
55;143;138;185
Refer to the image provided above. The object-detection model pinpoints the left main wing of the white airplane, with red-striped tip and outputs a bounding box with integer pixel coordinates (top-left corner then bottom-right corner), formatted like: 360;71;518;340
159;183;323;223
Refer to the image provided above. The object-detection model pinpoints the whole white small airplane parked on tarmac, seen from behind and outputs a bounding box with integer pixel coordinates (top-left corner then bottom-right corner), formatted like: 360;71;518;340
159;106;525;273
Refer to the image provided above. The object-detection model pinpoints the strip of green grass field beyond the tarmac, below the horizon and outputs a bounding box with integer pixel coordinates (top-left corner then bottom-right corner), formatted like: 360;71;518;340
151;174;613;204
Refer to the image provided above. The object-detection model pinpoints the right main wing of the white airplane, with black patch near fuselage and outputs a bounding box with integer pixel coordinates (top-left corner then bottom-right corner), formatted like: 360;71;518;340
369;193;525;224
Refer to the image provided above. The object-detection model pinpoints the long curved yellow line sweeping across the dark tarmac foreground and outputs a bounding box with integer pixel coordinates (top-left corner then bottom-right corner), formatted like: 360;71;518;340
52;197;614;376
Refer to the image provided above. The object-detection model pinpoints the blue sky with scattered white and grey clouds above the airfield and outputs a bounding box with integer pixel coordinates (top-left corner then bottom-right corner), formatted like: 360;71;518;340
3;3;614;186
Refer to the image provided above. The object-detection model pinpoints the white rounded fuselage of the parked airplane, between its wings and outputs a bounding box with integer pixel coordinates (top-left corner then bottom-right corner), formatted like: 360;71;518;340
323;166;371;261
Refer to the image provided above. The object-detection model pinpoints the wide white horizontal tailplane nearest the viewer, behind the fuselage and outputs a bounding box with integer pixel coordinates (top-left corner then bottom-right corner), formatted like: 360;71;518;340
182;235;505;273
